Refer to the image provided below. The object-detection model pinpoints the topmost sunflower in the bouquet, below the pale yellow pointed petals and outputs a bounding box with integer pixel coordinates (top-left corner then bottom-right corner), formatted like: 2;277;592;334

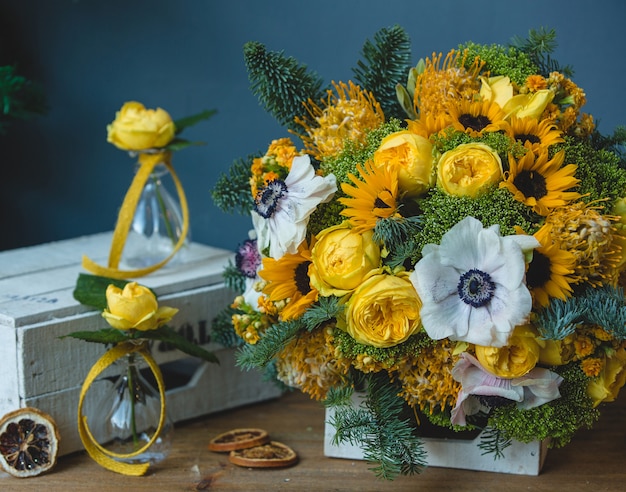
448;100;506;137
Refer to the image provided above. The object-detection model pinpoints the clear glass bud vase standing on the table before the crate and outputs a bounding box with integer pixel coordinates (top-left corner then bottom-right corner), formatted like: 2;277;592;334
89;353;174;464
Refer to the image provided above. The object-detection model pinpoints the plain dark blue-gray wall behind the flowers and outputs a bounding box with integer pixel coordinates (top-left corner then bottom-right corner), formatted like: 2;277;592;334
0;0;626;254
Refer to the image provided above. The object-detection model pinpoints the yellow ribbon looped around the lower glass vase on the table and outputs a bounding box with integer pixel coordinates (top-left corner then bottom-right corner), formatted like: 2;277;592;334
78;342;166;477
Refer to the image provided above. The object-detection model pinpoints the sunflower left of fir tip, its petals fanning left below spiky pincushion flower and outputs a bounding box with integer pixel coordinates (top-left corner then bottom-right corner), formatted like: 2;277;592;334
339;162;398;233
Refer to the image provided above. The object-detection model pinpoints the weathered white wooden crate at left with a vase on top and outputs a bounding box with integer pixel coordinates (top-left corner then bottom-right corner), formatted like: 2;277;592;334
0;233;280;454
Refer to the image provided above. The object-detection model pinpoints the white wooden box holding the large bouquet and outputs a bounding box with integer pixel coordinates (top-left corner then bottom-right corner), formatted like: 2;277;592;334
324;397;548;475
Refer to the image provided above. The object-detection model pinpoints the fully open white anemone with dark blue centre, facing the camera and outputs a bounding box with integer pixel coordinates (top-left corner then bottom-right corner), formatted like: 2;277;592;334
410;217;539;347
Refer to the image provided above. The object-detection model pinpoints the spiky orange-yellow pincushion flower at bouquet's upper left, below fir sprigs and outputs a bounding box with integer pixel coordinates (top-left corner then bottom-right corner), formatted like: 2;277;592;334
295;81;385;160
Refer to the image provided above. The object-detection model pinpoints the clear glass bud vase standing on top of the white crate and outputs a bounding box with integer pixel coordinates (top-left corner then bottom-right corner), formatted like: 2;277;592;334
122;164;191;269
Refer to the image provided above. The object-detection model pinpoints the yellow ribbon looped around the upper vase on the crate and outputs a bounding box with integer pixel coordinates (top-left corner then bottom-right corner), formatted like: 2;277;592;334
82;152;189;279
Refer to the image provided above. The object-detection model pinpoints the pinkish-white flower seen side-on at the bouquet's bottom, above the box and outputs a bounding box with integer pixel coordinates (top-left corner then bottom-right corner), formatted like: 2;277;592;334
451;352;563;425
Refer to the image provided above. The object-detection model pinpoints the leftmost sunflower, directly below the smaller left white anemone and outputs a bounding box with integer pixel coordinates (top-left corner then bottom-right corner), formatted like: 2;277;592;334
259;241;318;320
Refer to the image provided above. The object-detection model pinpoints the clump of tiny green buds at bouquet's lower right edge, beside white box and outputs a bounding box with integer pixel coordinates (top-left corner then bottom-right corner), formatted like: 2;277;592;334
489;363;600;448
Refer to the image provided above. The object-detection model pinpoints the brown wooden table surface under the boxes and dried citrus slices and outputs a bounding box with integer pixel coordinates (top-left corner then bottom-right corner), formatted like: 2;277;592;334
0;391;626;492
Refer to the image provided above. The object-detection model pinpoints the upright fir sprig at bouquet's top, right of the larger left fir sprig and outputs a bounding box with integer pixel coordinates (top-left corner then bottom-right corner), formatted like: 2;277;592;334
353;25;411;119
